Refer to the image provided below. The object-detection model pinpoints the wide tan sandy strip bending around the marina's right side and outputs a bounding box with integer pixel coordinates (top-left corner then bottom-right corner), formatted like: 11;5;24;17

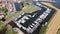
43;3;60;34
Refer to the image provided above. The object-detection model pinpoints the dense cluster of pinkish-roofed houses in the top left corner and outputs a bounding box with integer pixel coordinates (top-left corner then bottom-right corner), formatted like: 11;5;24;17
0;0;16;13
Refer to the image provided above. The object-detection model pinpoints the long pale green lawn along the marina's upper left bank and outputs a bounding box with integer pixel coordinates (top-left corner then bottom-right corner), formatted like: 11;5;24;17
6;5;39;21
